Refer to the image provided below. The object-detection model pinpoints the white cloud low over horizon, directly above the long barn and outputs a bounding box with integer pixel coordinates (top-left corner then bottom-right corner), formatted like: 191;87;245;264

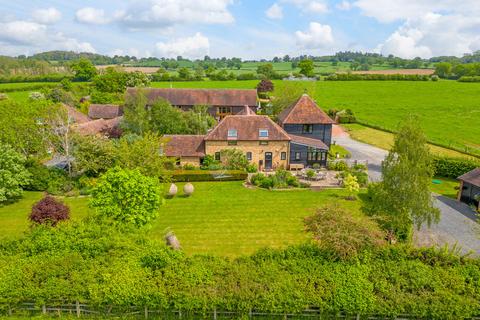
155;32;210;59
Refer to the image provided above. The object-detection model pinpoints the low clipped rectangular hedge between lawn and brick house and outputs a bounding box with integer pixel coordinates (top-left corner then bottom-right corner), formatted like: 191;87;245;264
172;170;248;182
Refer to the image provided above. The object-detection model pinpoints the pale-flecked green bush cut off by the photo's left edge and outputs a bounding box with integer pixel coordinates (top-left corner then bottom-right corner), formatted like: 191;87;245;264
0;144;30;205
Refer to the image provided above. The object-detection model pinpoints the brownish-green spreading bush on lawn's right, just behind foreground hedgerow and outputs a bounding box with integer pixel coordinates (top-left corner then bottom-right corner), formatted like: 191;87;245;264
304;205;385;259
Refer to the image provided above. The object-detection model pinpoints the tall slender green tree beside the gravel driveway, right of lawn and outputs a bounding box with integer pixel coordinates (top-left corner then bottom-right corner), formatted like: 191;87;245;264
369;116;440;241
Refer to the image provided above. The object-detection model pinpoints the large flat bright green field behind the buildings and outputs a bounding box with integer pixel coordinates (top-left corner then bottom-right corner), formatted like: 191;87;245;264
152;81;480;156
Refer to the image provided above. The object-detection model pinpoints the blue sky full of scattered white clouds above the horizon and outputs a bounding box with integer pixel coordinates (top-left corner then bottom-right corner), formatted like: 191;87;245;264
0;0;480;59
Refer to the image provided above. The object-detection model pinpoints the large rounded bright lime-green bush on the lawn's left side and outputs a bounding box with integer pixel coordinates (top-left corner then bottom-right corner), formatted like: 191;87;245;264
90;167;161;227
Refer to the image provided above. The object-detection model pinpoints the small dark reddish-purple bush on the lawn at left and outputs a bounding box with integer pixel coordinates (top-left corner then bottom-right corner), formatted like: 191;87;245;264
29;195;70;226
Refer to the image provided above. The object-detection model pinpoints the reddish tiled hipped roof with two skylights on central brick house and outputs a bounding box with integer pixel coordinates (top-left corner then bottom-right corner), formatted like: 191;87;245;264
205;115;290;141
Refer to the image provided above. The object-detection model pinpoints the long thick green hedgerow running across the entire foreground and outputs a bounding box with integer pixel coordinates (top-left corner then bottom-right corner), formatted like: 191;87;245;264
0;218;480;319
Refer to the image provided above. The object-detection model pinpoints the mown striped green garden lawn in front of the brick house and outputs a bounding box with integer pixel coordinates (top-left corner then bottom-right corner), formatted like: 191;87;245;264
0;181;361;256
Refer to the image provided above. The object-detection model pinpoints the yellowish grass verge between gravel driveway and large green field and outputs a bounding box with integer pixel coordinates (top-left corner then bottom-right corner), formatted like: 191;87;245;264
342;123;472;158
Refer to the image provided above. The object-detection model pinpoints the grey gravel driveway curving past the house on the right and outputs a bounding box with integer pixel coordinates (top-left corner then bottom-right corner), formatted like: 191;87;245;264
332;127;480;256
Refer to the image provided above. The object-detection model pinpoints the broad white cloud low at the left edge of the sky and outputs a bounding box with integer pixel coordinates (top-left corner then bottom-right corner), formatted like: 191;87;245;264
0;20;95;54
